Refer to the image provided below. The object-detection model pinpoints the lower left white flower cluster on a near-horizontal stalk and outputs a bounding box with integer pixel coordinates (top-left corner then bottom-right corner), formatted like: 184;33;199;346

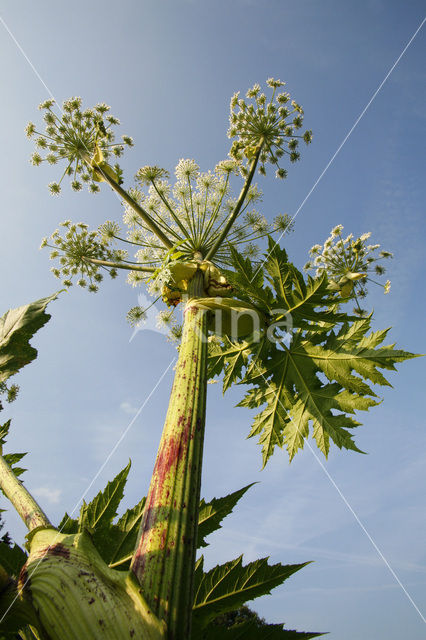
40;220;126;293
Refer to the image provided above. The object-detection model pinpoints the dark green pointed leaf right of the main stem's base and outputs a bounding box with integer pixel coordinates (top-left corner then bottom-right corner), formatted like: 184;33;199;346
193;556;309;629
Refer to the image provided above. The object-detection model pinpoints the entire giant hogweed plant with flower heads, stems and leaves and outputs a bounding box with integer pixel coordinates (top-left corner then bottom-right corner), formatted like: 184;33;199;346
0;79;413;640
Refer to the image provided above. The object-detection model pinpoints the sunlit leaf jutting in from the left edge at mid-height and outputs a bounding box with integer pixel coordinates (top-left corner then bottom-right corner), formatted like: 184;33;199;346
0;293;58;382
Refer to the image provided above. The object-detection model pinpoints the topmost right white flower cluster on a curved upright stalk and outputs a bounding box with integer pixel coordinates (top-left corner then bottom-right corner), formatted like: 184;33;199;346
228;78;312;178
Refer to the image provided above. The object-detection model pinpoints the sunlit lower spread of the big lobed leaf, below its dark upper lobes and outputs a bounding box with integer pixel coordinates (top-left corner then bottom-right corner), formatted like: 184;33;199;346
239;319;415;465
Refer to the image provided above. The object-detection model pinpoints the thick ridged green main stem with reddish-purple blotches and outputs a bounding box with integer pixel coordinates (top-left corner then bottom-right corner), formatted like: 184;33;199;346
131;271;207;640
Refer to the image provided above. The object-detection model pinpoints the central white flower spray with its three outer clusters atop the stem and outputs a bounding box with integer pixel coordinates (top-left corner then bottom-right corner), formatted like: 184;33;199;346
34;84;302;338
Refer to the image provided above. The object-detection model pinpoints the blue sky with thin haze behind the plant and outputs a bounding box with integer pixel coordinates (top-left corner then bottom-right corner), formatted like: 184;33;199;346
0;0;426;640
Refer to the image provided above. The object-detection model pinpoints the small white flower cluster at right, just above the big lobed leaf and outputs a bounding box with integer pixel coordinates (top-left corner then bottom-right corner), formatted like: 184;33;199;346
305;224;393;316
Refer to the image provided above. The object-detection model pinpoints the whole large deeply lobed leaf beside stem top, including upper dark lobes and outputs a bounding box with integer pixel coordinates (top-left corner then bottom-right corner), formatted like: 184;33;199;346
209;241;416;465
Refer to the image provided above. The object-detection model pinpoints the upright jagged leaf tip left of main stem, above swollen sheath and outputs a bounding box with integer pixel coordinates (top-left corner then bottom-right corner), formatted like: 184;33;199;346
78;461;131;531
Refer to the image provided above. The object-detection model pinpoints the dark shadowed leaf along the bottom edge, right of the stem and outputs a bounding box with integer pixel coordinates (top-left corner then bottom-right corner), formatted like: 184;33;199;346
198;620;324;640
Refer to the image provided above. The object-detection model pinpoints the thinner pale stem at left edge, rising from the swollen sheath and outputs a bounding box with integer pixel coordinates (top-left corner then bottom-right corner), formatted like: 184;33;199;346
0;455;52;531
